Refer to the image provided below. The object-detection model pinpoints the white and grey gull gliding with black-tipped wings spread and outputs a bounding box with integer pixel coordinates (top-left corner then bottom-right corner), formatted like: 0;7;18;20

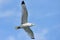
16;1;35;39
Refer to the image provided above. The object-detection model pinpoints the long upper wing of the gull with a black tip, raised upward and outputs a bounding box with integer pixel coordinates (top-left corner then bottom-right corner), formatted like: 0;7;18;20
21;1;28;24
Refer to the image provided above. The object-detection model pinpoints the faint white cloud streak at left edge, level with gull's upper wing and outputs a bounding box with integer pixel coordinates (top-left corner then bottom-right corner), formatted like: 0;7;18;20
0;8;17;18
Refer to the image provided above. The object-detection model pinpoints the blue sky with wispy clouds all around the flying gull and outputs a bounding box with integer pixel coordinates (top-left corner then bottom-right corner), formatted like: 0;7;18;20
0;0;60;40
